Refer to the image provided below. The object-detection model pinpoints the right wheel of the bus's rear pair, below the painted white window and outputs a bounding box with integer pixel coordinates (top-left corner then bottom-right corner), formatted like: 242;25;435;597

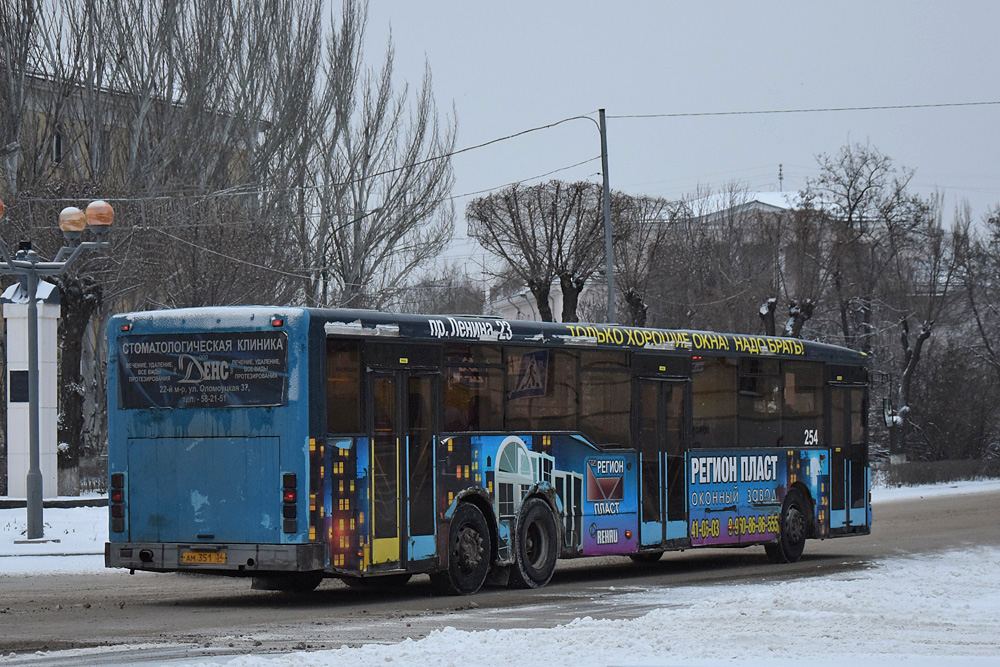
510;498;559;588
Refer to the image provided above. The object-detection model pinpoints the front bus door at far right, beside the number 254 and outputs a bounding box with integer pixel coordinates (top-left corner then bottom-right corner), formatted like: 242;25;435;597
829;385;868;530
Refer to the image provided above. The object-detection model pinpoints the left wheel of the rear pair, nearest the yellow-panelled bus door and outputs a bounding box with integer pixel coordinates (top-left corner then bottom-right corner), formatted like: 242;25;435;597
431;503;492;595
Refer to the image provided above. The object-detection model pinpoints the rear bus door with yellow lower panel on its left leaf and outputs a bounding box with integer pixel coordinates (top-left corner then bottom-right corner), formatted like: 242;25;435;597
369;370;439;569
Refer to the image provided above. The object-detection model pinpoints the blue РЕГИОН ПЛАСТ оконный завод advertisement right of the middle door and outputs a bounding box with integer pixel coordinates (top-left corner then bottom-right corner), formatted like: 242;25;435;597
687;450;829;546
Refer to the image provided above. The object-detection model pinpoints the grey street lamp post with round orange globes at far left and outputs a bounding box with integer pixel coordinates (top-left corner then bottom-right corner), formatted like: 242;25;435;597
0;200;115;540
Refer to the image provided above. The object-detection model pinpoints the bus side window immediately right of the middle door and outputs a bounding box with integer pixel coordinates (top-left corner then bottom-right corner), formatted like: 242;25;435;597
691;357;738;448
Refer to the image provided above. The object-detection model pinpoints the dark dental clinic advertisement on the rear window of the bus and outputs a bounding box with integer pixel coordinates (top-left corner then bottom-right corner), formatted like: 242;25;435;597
118;331;288;408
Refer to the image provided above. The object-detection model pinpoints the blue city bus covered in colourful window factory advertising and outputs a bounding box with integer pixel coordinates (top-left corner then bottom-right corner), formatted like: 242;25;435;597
105;306;872;594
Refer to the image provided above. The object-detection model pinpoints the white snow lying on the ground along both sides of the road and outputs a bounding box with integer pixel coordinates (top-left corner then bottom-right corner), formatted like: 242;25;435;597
0;480;1000;667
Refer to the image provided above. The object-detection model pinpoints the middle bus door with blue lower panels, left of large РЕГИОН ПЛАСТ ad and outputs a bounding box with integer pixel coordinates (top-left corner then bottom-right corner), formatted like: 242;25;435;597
638;378;689;547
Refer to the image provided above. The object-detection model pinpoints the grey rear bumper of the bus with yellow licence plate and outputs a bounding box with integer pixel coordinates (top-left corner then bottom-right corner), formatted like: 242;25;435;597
104;542;326;576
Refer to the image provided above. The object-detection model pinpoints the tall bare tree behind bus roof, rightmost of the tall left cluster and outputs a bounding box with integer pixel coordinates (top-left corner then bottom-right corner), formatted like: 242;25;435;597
313;8;456;307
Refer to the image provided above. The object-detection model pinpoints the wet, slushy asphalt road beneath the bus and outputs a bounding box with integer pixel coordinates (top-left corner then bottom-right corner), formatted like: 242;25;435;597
0;492;1000;665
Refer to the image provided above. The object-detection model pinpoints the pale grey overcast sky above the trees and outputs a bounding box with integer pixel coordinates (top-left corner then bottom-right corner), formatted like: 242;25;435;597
367;0;1000;264
